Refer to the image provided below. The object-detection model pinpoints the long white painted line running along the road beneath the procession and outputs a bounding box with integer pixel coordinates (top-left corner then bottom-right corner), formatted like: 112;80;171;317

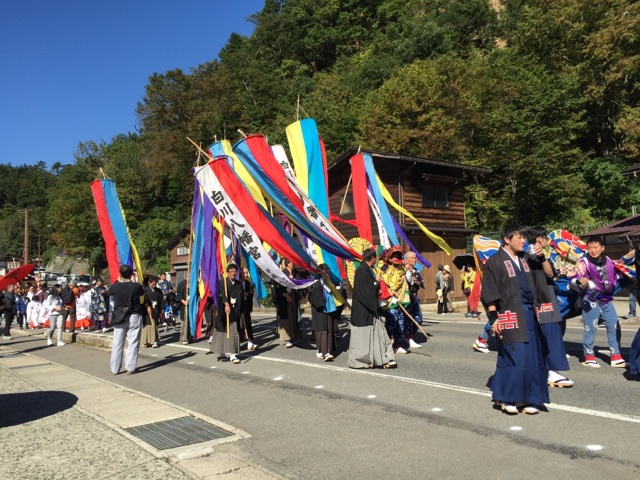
167;344;640;423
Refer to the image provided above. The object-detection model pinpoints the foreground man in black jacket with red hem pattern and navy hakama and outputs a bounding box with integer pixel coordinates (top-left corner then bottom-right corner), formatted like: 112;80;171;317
481;224;550;415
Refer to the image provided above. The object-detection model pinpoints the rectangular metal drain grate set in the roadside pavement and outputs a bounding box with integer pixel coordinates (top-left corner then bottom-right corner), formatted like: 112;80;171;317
125;417;233;450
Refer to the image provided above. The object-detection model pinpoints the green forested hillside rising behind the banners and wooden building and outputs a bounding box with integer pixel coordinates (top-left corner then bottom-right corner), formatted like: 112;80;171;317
0;0;640;269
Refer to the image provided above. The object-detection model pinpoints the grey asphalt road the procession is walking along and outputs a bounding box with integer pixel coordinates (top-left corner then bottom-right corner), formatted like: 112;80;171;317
6;314;640;480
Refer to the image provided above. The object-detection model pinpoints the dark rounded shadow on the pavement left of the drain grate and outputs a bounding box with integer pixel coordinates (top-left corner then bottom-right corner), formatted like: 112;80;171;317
0;390;78;428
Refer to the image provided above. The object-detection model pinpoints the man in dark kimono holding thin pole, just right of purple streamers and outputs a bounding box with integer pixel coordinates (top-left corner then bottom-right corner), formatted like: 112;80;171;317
209;263;244;363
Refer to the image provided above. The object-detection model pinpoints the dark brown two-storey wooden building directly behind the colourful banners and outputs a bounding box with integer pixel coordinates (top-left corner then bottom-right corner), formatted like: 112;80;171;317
328;147;490;303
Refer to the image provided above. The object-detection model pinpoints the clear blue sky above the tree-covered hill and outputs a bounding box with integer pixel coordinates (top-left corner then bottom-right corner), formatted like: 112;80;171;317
0;0;264;166
